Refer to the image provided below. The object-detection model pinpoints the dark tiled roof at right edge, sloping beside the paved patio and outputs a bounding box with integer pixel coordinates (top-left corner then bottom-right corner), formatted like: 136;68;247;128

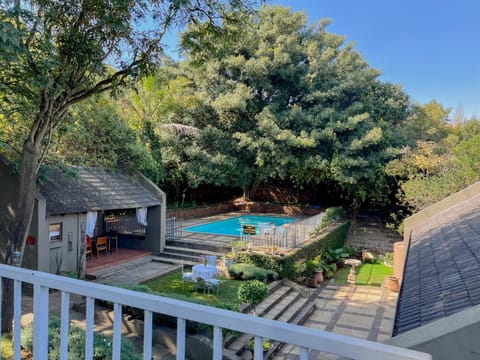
393;194;480;335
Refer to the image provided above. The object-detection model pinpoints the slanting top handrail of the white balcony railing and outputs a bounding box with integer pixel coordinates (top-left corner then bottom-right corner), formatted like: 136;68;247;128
0;264;431;360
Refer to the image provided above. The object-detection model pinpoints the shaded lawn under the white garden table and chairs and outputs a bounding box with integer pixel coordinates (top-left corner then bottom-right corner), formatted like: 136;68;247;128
143;271;242;310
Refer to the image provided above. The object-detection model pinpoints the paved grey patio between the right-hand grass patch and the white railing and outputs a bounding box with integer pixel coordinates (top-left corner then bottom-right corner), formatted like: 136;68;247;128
275;284;397;360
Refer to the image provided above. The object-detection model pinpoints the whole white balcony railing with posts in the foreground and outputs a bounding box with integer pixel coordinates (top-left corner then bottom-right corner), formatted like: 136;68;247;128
0;265;431;360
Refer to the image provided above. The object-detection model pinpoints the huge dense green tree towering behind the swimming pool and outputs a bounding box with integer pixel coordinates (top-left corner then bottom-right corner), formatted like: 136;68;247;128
176;7;408;204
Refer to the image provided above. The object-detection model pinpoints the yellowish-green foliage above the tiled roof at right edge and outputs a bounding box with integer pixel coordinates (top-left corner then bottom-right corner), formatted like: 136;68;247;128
387;114;480;212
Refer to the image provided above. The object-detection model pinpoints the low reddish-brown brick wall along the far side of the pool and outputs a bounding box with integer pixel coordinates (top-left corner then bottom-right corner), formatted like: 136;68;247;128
167;201;321;219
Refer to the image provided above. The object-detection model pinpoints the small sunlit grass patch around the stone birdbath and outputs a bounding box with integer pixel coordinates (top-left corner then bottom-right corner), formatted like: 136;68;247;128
334;262;393;286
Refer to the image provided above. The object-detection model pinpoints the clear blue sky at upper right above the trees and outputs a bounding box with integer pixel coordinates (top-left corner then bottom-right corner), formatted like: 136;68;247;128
166;0;480;118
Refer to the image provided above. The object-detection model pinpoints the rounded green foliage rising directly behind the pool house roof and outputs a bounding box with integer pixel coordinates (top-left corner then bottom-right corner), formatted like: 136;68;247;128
53;95;161;183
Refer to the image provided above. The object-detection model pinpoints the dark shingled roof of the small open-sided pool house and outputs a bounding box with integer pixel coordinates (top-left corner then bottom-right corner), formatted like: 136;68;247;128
39;167;161;215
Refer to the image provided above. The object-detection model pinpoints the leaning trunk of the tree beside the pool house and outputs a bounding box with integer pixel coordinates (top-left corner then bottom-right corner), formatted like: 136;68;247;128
1;129;41;333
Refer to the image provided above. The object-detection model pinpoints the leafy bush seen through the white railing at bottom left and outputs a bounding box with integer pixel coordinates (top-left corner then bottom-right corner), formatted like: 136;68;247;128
22;317;142;360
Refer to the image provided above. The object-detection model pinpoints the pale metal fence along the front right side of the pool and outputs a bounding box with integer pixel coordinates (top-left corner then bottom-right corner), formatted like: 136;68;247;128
240;213;325;253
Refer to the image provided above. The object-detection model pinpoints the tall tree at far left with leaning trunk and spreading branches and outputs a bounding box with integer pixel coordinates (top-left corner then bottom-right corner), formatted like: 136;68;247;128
0;0;255;329
